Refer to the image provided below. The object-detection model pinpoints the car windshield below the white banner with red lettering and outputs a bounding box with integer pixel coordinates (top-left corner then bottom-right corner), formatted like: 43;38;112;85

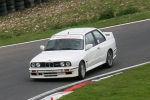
45;39;83;51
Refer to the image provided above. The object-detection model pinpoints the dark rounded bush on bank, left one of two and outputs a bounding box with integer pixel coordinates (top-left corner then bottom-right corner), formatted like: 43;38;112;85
99;9;114;20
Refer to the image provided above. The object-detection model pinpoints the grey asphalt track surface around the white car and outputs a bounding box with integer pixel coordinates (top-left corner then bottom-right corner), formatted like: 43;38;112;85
0;20;150;100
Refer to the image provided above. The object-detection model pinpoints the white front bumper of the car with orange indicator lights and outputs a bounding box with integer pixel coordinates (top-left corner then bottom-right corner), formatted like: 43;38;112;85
29;66;78;79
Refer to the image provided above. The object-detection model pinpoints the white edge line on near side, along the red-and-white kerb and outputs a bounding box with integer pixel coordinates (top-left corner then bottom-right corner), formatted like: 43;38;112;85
28;62;150;100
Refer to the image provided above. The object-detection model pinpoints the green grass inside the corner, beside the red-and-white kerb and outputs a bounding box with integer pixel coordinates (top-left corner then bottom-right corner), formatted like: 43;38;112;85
59;64;150;100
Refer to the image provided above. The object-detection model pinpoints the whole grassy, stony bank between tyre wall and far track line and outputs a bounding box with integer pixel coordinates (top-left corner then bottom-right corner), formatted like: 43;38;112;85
0;0;150;46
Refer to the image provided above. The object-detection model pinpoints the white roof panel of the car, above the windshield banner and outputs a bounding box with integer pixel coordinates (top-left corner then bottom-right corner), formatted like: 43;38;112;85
55;28;97;35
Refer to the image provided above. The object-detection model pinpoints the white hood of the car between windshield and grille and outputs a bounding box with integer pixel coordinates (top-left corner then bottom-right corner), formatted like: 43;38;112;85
31;50;83;62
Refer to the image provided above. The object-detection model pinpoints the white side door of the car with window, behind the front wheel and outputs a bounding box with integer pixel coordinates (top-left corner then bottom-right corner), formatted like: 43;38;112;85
85;32;99;67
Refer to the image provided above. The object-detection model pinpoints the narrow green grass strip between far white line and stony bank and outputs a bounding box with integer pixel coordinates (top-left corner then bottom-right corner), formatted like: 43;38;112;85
0;11;150;46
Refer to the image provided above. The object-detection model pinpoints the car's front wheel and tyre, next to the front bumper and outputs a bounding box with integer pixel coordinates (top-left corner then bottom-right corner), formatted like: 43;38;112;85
78;61;86;79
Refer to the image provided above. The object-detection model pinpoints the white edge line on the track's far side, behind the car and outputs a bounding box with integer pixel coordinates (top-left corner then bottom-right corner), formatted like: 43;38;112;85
0;19;150;48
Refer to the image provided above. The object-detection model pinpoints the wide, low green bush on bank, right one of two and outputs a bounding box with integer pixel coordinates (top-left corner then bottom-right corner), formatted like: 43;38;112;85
116;7;139;16
